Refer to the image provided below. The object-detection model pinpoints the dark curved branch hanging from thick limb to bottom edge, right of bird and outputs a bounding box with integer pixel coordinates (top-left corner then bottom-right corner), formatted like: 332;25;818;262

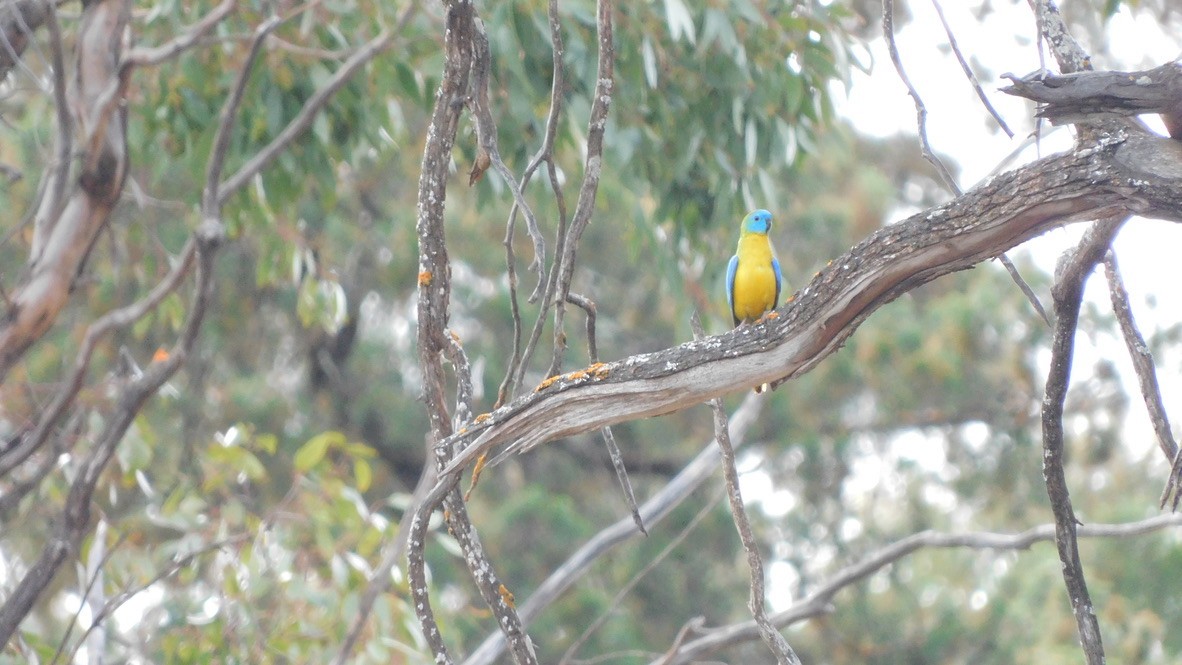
1043;217;1124;665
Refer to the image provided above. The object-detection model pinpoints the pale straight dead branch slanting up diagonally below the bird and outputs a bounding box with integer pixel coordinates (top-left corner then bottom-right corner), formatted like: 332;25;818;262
465;391;765;665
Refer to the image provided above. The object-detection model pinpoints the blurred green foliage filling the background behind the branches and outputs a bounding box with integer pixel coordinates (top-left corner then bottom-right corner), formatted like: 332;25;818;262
0;0;1182;663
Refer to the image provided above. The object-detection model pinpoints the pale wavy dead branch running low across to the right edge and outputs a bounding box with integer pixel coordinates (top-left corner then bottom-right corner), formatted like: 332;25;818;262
654;515;1182;665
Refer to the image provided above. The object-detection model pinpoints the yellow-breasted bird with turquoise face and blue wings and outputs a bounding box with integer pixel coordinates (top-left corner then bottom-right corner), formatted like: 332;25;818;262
727;210;784;392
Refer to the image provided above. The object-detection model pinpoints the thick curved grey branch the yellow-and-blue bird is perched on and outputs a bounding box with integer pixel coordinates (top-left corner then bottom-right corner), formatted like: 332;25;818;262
442;133;1182;477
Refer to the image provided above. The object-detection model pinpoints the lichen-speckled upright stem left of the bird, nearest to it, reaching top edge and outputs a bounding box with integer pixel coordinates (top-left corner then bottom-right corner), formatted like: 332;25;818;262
546;0;616;377
